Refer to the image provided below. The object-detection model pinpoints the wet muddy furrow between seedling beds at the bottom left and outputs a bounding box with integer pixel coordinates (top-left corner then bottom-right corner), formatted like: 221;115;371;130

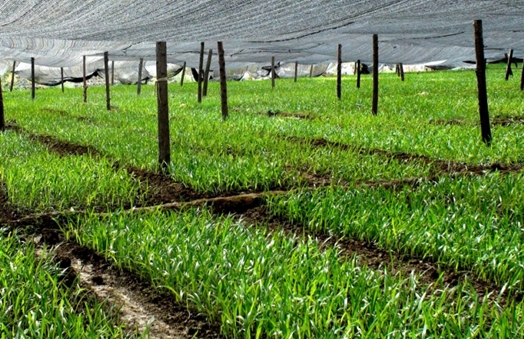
29;225;222;339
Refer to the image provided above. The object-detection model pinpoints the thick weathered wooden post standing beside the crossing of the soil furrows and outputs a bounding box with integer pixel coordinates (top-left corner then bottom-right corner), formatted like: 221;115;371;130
156;41;171;172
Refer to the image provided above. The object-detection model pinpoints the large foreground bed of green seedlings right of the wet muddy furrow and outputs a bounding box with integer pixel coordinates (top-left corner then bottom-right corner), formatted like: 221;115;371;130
64;209;524;338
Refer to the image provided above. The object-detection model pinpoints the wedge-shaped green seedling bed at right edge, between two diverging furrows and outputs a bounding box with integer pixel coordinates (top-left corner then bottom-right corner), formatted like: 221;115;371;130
268;173;524;297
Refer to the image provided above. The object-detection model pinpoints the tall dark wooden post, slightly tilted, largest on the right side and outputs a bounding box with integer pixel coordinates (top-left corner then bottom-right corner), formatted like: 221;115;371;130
473;20;491;146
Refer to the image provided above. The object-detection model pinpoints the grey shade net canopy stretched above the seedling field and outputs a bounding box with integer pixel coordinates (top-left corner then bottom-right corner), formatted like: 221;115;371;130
0;0;524;68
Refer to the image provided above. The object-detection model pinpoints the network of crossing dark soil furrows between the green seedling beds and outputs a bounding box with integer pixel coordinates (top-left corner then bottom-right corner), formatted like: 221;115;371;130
0;70;523;338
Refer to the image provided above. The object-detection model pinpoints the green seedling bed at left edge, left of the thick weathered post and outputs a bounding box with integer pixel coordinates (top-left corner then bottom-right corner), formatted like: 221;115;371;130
0;131;143;212
